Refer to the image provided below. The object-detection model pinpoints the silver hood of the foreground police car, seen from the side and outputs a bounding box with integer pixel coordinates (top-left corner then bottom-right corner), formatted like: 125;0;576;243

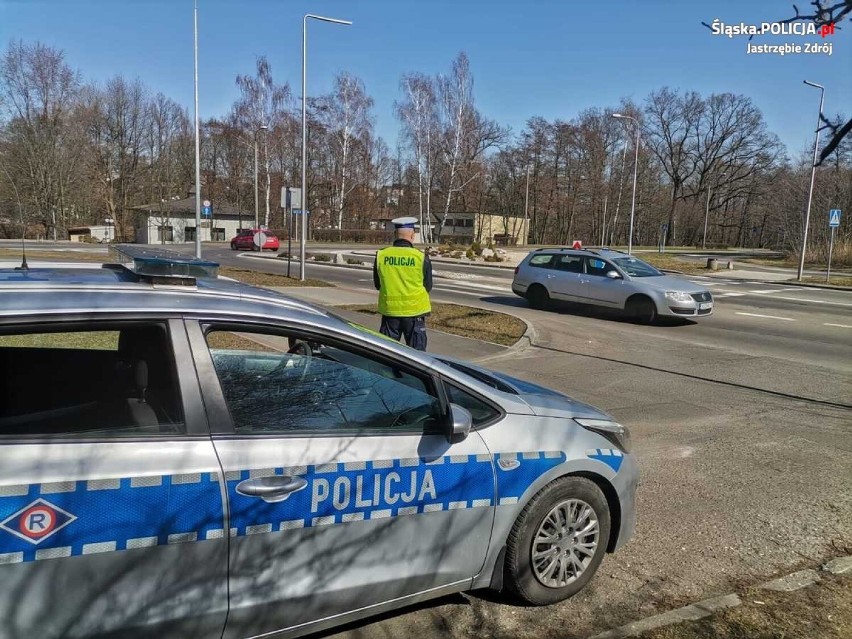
435;355;612;419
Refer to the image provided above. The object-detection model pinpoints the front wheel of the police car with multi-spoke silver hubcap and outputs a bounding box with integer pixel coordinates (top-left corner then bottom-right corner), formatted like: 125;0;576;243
505;477;610;606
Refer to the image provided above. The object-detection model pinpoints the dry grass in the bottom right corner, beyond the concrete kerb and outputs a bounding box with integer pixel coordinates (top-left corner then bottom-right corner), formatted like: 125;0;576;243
640;574;852;639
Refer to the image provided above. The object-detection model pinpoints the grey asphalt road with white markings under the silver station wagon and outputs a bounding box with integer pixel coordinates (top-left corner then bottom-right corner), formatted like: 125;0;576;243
3;245;852;639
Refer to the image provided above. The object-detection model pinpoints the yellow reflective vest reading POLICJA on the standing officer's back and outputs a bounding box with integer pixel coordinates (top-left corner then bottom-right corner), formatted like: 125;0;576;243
376;246;432;317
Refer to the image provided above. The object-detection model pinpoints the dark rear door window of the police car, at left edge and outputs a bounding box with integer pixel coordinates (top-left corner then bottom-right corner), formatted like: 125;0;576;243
0;322;186;438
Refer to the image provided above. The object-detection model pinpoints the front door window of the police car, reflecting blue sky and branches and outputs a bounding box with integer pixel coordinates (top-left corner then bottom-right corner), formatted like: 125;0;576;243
207;328;444;434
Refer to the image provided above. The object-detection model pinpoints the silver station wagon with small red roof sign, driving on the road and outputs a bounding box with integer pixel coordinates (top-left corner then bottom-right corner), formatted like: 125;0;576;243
512;248;713;324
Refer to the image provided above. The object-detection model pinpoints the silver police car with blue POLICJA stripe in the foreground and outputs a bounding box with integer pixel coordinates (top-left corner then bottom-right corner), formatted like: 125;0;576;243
0;247;638;637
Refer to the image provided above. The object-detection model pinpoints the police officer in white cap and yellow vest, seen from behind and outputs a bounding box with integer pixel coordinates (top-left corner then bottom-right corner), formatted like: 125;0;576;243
373;217;432;351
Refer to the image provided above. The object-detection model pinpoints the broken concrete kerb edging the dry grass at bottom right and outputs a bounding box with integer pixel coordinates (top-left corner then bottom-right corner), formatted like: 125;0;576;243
589;555;852;639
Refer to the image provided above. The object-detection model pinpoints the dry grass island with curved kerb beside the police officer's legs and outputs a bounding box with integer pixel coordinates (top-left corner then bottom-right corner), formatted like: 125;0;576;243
338;303;527;346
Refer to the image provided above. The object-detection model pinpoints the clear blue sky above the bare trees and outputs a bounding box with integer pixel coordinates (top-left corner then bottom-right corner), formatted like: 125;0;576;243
0;0;852;154
